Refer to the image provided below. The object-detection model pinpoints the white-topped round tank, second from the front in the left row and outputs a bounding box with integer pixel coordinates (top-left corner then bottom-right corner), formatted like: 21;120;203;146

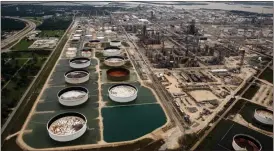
57;86;89;106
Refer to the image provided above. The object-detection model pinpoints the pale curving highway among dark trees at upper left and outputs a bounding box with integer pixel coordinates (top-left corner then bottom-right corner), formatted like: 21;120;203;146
1;17;36;52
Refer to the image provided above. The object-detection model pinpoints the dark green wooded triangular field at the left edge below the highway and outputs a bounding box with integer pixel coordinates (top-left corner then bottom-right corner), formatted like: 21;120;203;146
1;51;50;122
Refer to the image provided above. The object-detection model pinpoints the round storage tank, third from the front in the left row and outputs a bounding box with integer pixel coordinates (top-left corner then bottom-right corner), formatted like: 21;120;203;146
64;69;89;84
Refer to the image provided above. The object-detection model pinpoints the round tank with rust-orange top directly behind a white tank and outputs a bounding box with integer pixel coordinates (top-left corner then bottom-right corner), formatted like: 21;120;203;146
106;68;130;81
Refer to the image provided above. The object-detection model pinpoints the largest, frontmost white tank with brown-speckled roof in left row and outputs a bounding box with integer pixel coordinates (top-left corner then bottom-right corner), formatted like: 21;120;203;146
47;112;87;142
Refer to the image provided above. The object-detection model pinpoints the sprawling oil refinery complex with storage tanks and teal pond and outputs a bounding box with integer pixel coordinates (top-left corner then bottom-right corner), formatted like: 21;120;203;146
1;2;273;151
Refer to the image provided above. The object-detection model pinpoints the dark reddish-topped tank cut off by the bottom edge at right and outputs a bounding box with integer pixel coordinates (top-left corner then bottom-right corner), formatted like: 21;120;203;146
232;134;262;151
